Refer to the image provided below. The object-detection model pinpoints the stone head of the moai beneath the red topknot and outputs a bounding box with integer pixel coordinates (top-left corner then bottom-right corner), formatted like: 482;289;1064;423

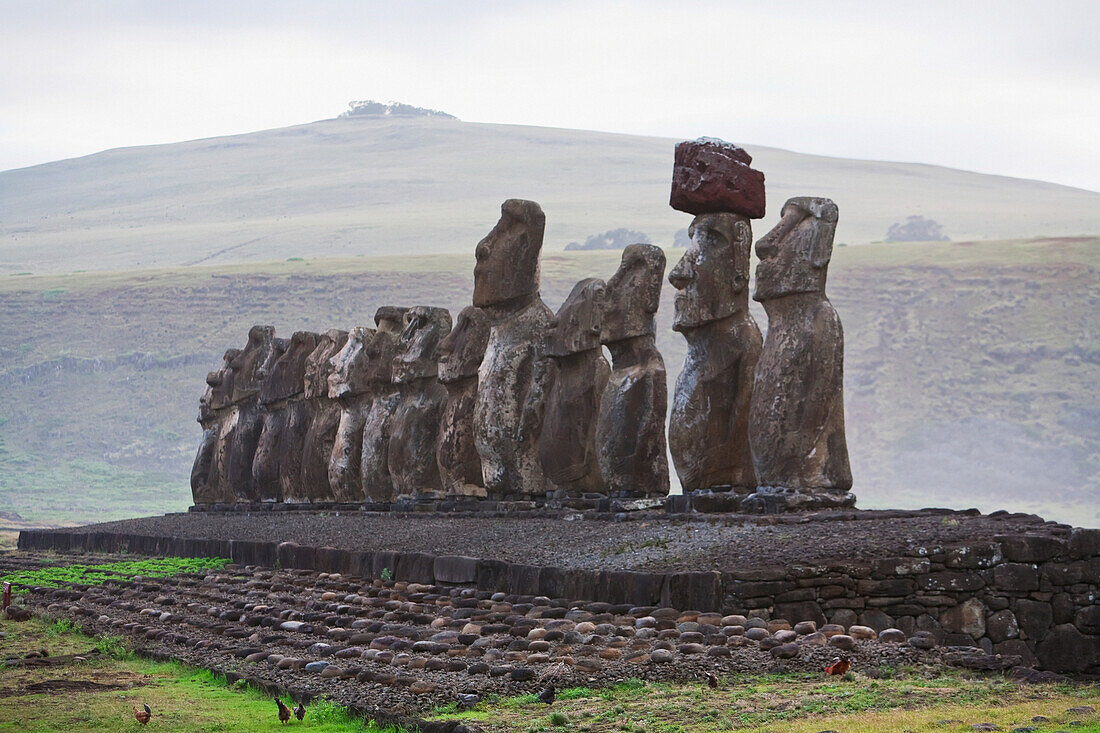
669;214;752;331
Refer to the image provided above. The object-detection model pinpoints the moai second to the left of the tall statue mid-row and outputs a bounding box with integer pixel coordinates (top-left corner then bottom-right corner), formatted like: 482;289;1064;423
387;306;451;501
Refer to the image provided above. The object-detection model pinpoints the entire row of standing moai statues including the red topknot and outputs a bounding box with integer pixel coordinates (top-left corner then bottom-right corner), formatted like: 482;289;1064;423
191;139;855;512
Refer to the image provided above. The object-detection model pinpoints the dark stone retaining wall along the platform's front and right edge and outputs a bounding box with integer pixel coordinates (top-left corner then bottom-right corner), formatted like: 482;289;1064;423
19;528;1100;674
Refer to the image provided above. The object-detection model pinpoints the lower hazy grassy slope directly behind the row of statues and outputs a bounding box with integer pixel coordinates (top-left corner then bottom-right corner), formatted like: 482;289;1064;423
0;239;1100;528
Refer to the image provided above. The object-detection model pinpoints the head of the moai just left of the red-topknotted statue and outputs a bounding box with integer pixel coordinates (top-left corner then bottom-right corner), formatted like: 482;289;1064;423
600;244;664;343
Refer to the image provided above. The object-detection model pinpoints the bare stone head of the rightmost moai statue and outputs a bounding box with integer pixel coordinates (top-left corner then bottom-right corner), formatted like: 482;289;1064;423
752;197;837;300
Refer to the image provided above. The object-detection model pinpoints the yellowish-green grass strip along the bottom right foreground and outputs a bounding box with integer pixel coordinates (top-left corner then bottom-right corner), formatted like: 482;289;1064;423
422;668;1100;733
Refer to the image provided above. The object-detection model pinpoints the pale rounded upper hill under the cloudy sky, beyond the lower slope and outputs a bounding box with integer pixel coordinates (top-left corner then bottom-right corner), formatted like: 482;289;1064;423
0;117;1100;274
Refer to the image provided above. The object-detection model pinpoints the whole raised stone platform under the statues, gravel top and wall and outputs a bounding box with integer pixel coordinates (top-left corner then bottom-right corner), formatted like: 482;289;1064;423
20;510;1100;674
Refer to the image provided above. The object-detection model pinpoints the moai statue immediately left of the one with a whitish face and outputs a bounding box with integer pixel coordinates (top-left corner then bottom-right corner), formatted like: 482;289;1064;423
301;328;348;502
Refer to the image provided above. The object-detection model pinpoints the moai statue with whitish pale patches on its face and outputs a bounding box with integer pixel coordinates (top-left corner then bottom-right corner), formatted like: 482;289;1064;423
329;326;374;502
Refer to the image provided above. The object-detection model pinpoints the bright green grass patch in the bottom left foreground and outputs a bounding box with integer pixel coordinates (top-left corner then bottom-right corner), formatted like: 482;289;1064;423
0;620;403;733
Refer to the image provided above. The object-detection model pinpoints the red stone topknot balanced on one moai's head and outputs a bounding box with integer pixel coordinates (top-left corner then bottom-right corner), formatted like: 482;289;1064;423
669;138;765;219
